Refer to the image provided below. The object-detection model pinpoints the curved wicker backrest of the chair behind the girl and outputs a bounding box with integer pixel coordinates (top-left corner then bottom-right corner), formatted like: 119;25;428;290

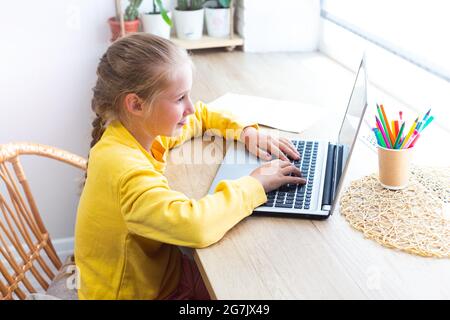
0;143;87;300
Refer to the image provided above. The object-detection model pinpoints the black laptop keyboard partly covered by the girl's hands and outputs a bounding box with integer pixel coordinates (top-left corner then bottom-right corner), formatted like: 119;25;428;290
263;140;319;209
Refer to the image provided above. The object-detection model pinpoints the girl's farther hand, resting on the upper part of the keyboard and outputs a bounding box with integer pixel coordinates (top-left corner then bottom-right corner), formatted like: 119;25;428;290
241;127;300;161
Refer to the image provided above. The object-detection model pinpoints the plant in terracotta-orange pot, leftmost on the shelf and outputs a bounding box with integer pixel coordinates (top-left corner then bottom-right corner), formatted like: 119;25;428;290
108;0;142;41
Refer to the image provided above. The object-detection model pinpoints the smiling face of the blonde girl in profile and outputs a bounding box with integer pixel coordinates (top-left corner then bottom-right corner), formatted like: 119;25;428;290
146;64;194;136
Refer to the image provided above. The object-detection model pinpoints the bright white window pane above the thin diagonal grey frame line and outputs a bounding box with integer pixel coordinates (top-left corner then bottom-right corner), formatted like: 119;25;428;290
322;0;450;81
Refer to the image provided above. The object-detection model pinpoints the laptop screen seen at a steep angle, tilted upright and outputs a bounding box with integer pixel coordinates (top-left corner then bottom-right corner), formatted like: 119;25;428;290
338;58;367;148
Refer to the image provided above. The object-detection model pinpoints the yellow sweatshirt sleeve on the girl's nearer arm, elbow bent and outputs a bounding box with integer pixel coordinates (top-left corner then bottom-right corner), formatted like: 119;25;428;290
119;167;267;248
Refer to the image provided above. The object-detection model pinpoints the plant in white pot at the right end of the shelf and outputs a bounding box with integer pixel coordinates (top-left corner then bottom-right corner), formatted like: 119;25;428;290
205;0;231;38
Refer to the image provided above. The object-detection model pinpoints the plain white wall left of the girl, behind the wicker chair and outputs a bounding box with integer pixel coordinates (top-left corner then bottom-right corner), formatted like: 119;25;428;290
0;0;121;244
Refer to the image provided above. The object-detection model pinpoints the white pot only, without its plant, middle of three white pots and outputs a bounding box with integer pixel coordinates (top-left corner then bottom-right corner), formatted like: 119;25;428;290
174;8;204;40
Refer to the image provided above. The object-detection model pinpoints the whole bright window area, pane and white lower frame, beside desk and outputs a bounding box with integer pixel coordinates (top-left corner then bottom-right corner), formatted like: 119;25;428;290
320;0;450;129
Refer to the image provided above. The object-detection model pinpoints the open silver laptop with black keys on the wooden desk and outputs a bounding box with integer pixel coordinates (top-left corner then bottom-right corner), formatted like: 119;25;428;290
209;57;367;219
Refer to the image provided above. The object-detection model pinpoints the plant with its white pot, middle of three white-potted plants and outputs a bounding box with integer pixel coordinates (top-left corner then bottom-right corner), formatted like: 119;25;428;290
174;0;204;40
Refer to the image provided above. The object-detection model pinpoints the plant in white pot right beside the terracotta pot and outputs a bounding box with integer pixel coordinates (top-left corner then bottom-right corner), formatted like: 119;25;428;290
141;0;172;39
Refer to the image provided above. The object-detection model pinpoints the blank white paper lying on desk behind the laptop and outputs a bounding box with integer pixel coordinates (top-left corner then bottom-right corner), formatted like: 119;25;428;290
208;93;329;133
